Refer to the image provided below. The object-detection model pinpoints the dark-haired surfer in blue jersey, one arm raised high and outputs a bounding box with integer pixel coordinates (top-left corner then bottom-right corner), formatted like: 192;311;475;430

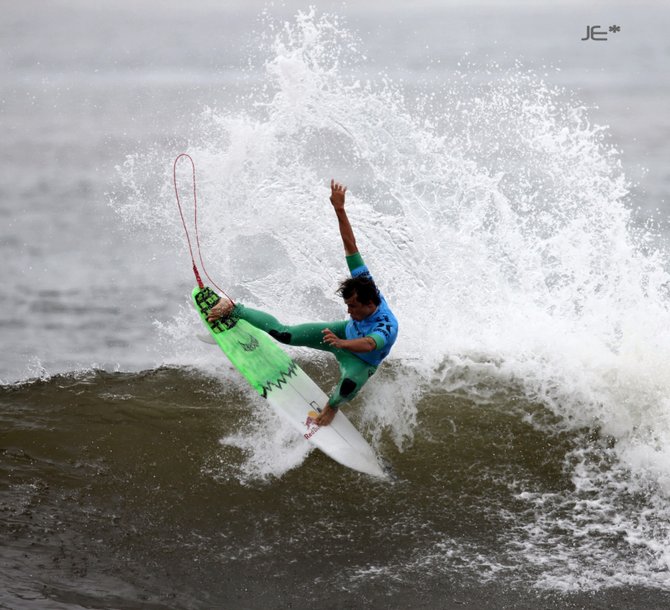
207;180;398;426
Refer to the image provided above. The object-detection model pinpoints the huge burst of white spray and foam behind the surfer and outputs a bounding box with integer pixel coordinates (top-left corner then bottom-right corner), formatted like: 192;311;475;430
101;10;670;584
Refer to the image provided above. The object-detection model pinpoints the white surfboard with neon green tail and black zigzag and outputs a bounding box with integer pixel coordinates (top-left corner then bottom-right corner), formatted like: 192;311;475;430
192;287;387;478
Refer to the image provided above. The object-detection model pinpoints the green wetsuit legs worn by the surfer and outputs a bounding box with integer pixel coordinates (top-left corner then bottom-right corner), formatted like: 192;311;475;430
231;303;377;408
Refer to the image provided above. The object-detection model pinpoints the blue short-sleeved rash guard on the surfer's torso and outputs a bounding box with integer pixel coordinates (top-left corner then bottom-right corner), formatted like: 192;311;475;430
345;252;398;366
